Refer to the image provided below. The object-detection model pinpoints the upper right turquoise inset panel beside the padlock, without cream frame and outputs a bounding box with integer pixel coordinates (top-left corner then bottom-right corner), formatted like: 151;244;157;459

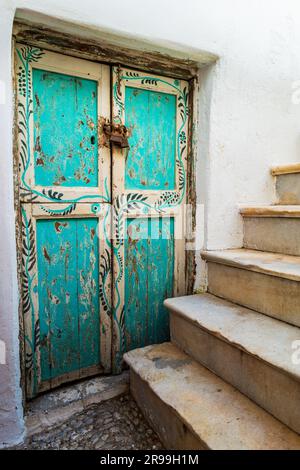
125;87;176;190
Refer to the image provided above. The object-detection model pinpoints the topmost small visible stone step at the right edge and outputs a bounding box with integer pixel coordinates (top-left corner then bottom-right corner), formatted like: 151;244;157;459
272;163;300;204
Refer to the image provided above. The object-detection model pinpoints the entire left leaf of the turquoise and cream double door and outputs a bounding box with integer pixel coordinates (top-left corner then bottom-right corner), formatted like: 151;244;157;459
16;44;111;398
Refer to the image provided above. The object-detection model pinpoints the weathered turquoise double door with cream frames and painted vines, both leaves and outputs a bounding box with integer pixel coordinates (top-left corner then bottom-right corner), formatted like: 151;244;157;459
16;44;188;398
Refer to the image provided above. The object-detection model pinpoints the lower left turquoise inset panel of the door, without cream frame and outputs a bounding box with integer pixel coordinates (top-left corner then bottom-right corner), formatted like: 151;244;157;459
36;218;101;381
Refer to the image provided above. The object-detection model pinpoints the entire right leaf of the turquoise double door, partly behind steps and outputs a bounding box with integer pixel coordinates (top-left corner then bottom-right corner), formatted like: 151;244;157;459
112;68;188;371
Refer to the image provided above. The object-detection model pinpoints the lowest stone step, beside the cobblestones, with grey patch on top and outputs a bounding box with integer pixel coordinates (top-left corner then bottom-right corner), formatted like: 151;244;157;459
124;343;300;450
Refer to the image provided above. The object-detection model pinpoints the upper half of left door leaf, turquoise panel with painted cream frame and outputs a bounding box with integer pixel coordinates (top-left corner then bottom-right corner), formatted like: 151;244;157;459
16;44;111;204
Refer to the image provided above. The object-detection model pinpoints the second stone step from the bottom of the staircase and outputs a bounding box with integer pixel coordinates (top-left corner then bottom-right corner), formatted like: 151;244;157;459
165;294;300;433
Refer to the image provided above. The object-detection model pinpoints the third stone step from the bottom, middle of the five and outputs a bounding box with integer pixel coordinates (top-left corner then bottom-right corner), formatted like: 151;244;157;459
202;248;300;326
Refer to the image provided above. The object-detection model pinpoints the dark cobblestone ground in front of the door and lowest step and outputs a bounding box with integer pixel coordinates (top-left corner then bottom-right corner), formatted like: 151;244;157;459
18;395;163;450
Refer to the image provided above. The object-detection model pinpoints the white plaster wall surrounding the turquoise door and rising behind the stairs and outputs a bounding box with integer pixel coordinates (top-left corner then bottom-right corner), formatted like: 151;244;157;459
0;0;300;443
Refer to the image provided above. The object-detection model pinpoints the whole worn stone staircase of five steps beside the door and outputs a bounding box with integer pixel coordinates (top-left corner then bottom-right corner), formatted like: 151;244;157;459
124;164;300;450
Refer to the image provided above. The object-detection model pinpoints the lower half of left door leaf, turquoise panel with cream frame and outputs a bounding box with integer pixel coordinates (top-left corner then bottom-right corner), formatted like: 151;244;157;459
22;203;111;398
